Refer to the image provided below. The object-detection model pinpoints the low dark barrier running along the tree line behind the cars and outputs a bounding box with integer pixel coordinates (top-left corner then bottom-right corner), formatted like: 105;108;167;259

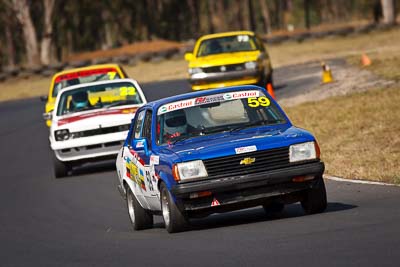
0;24;396;82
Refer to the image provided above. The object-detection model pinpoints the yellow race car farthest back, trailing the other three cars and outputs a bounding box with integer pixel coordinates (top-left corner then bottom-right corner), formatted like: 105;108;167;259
185;31;272;90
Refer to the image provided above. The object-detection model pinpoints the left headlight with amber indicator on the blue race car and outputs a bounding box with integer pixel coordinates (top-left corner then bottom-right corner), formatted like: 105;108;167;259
173;160;208;181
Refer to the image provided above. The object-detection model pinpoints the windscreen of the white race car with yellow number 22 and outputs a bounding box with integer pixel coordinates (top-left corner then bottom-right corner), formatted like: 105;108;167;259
57;82;143;116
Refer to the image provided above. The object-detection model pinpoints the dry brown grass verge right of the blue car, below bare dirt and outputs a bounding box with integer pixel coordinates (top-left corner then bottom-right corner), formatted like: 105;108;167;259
286;87;400;184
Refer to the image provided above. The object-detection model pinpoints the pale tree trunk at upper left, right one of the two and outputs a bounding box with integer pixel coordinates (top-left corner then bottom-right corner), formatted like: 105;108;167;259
40;0;55;65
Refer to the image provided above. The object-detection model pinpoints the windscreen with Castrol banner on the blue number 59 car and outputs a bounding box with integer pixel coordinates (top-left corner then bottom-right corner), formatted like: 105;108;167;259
157;90;286;145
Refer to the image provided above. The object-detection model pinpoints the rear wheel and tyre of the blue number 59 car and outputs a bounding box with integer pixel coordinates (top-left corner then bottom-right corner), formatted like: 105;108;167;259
126;187;153;230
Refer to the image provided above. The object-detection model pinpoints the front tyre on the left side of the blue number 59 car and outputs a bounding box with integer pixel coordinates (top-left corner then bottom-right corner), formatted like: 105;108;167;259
160;184;187;233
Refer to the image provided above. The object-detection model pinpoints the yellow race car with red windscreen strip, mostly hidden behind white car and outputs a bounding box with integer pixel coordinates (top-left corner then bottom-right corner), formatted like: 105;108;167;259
41;64;128;127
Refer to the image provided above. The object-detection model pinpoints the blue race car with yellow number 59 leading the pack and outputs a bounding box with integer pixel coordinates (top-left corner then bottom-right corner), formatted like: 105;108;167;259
116;85;327;233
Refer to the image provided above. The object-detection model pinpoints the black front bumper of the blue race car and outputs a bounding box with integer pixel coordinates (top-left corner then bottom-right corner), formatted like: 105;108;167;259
171;162;325;213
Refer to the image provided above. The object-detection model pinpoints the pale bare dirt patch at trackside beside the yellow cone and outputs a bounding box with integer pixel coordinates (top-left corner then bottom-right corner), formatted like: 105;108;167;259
278;60;396;107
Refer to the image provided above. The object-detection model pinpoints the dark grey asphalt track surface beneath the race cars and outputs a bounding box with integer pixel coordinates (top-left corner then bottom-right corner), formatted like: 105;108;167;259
0;61;400;267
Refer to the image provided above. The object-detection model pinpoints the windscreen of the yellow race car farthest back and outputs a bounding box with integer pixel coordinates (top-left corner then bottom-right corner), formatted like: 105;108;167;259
197;34;260;57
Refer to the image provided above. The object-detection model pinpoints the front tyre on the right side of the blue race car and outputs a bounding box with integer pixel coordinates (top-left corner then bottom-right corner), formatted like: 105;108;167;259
301;177;328;214
